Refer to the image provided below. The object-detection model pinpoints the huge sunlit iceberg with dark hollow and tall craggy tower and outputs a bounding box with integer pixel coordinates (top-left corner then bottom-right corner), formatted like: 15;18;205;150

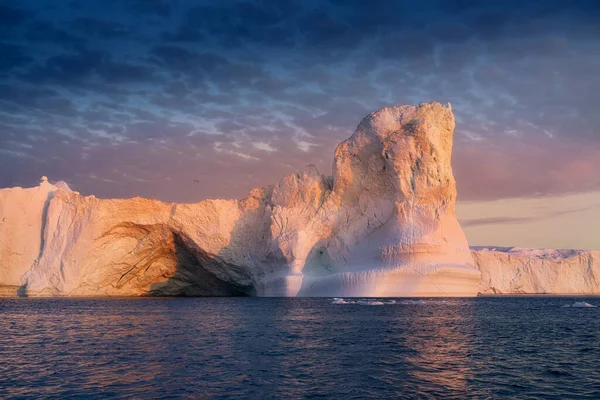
0;103;480;296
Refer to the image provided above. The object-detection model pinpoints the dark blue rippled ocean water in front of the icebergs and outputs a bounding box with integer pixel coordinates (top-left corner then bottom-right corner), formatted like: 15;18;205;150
0;297;600;399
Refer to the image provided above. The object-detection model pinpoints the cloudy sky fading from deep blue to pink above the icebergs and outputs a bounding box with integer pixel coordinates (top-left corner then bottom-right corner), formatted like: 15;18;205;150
0;0;600;250
